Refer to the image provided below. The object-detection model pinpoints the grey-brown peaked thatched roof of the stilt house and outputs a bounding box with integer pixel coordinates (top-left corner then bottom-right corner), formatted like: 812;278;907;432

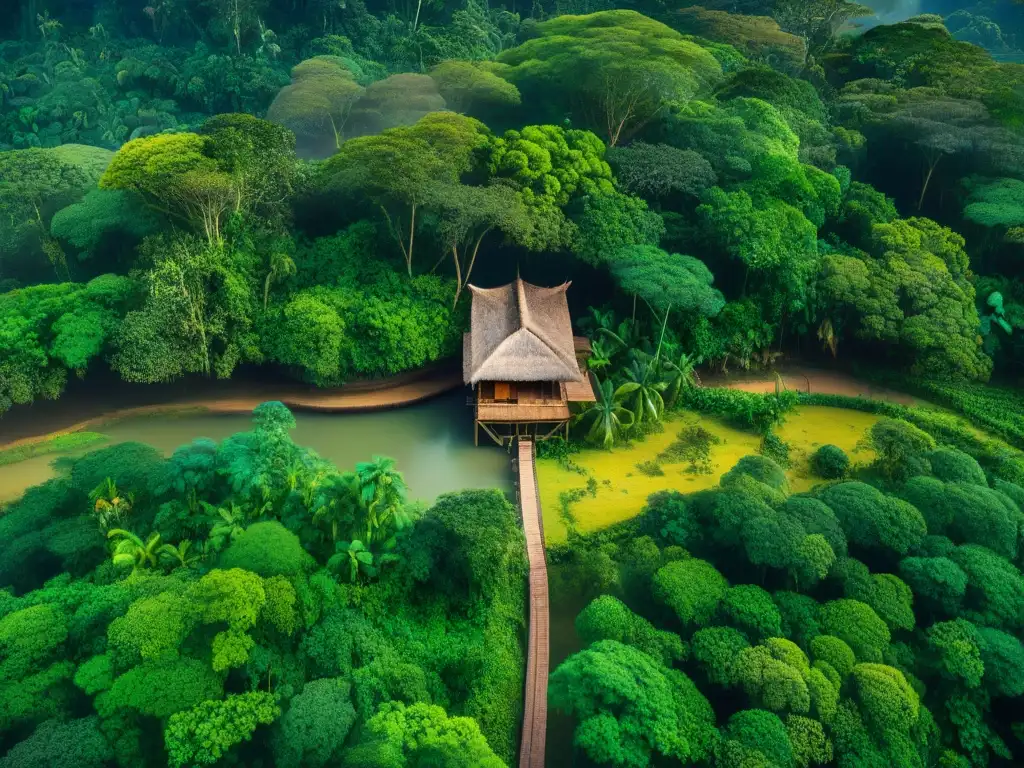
462;279;583;384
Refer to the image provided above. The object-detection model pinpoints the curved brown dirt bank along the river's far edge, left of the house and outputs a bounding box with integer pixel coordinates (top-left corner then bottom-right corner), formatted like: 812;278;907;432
0;366;462;449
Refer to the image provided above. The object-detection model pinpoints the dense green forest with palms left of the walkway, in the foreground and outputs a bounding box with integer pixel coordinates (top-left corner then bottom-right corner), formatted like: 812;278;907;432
0;402;526;768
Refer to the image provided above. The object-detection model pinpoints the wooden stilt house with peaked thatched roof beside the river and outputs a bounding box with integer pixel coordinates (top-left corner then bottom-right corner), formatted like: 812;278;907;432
463;279;596;445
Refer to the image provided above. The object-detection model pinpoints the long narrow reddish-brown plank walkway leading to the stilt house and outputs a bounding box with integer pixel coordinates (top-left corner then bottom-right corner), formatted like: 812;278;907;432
518;438;549;768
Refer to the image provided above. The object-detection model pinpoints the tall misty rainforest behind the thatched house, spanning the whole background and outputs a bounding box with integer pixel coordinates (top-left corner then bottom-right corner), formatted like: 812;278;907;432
0;0;1024;417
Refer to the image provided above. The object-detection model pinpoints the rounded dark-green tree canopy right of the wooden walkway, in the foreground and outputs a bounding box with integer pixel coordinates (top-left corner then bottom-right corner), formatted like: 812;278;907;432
549;419;1024;768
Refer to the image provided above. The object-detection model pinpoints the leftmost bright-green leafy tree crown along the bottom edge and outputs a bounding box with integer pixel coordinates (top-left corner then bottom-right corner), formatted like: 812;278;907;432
164;691;281;768
